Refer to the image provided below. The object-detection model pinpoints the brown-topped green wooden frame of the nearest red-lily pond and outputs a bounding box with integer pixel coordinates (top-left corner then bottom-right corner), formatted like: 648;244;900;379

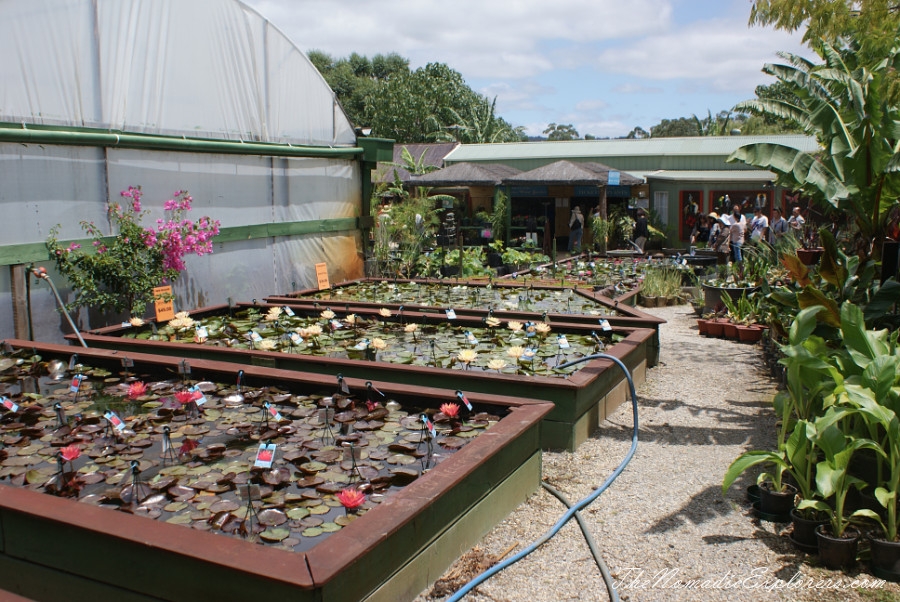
0;340;552;602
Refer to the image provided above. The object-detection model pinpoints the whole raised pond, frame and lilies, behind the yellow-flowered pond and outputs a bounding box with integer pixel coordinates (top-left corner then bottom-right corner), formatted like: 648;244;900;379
266;277;665;367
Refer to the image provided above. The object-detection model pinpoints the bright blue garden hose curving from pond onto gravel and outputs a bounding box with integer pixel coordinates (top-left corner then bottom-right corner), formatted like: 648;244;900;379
447;353;638;602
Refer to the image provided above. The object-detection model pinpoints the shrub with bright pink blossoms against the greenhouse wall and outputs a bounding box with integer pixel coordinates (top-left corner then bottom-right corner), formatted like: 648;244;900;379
47;186;219;316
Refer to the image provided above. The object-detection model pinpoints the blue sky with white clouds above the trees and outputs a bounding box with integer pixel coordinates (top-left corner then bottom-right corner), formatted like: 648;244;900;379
244;0;810;137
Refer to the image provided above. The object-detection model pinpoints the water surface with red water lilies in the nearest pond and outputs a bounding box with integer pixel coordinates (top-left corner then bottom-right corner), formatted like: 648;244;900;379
0;350;500;551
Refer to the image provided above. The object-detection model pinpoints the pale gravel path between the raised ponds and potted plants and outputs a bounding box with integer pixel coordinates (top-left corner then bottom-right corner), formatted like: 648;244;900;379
417;306;900;602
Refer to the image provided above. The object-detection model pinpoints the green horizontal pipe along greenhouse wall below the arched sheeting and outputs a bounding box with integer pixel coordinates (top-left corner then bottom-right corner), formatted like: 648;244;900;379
0;126;363;159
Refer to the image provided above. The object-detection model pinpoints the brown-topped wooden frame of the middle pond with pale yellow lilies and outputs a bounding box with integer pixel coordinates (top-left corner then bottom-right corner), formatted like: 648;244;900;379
70;304;656;450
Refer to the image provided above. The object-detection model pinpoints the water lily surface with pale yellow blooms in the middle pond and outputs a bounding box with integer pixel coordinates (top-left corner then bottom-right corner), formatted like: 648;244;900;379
120;305;622;377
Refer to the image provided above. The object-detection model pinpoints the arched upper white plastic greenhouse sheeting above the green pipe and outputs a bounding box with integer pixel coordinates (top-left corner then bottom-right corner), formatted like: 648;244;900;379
0;0;356;146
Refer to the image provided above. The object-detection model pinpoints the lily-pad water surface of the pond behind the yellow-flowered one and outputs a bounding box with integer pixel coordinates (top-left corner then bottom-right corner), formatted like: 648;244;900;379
285;276;618;316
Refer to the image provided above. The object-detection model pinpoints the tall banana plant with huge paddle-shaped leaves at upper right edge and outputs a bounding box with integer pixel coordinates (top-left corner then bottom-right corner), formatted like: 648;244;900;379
729;39;900;257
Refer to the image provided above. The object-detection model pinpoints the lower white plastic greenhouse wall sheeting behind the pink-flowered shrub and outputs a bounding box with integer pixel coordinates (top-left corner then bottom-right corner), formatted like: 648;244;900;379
0;139;363;341
